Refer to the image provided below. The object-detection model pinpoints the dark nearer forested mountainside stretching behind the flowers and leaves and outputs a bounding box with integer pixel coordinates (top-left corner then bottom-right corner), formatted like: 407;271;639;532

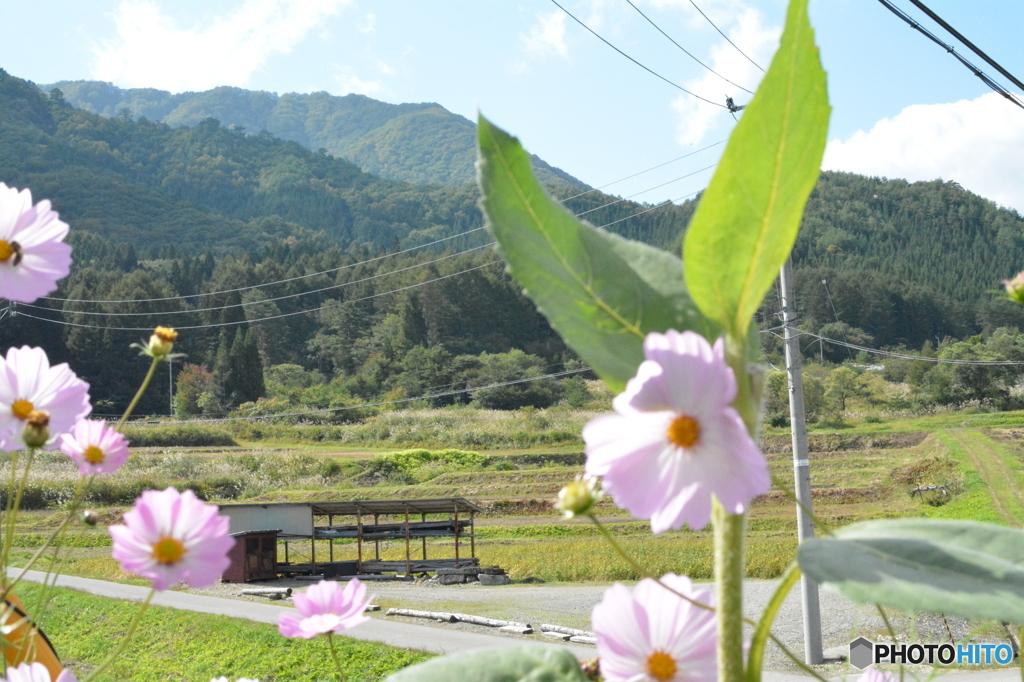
0;71;1024;415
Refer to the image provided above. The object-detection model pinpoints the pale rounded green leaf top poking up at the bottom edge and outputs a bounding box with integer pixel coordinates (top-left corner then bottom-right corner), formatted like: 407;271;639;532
384;646;587;682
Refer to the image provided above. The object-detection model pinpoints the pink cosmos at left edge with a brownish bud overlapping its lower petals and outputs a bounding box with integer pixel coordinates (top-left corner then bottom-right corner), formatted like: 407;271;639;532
0;346;92;450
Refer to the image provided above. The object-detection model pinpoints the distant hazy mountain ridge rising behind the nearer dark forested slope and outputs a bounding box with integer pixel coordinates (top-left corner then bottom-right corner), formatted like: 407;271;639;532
42;81;589;188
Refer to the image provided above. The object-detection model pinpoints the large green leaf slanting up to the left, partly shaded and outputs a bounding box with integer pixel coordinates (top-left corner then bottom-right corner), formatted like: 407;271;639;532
478;116;720;391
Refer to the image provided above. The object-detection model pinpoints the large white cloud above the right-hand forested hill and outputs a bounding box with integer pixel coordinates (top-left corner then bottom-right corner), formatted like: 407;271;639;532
822;92;1024;212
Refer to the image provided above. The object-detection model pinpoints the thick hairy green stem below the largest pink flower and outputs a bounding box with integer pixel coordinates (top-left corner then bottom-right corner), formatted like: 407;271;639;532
712;499;744;682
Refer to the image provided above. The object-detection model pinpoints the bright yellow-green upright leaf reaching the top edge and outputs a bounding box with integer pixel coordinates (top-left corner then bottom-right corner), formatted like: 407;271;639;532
683;0;829;338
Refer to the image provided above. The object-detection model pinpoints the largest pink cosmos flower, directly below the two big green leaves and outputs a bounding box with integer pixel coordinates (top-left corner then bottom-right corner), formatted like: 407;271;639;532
583;331;771;532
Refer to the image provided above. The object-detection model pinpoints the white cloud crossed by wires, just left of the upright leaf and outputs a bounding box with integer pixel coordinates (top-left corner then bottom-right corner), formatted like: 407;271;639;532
672;2;782;145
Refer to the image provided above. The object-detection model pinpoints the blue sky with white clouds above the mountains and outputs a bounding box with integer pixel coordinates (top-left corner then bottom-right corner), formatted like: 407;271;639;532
0;0;1024;213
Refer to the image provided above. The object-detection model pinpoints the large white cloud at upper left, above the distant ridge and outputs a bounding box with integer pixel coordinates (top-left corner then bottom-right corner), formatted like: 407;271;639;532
92;0;350;92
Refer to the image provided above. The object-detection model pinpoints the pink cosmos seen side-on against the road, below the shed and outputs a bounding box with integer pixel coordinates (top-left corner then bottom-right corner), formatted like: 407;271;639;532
278;578;370;639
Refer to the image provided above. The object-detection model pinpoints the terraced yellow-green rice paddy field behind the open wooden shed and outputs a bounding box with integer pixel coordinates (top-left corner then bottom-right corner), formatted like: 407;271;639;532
12;403;1024;582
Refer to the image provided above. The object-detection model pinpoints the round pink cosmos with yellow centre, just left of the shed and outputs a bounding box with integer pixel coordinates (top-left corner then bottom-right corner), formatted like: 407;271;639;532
110;487;234;591
